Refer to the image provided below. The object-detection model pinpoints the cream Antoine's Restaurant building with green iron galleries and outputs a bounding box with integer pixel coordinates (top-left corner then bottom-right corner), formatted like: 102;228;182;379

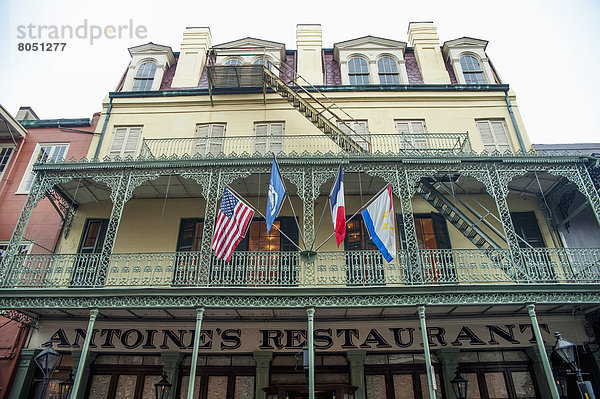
0;22;600;399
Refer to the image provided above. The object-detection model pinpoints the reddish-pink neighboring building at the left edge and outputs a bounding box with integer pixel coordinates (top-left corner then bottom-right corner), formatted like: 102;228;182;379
0;107;100;399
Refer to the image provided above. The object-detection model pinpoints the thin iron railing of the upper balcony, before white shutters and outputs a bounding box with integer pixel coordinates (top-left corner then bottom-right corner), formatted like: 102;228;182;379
139;133;472;160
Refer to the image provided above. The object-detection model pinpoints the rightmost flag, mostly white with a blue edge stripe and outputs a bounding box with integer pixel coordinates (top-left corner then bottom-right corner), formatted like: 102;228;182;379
362;184;396;262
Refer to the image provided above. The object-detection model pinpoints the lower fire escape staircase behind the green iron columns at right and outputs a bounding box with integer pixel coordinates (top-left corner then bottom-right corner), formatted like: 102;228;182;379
416;178;531;281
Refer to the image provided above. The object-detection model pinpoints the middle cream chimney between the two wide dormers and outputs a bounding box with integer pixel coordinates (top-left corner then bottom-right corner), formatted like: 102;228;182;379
296;25;323;85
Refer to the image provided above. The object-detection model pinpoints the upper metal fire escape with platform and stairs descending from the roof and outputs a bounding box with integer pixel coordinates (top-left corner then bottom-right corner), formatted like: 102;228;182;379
207;64;370;154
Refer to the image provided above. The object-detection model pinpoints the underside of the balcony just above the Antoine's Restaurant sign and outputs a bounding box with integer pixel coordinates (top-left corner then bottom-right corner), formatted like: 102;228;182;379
20;304;600;322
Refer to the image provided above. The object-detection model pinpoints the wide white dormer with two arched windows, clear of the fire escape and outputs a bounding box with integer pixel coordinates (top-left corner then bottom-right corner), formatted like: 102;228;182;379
333;36;408;85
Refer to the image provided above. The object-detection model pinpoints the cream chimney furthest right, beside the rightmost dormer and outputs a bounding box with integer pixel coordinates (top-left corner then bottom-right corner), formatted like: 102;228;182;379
408;22;450;84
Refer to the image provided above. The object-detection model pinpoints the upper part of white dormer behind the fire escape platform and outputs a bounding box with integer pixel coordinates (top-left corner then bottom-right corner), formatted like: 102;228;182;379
212;37;289;72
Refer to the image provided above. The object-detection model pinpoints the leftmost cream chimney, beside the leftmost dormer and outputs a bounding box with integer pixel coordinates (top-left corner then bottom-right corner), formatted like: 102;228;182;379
171;28;212;88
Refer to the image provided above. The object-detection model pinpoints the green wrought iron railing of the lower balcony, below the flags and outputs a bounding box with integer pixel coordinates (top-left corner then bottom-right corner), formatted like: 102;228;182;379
1;248;600;288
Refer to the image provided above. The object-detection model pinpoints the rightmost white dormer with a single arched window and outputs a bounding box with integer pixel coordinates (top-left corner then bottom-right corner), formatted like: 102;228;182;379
442;37;498;84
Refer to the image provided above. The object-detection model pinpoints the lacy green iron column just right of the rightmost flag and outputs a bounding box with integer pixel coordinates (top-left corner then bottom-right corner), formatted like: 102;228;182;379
396;168;423;283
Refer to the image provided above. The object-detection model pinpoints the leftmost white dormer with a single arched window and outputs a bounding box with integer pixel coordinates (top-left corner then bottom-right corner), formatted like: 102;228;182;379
122;42;175;91
